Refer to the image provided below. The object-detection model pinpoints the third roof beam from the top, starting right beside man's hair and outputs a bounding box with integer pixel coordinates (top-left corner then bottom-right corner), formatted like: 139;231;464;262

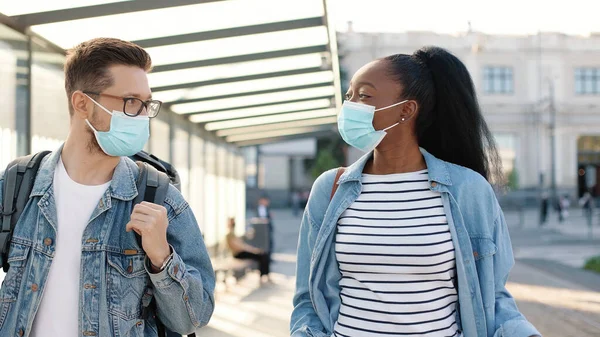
152;45;327;73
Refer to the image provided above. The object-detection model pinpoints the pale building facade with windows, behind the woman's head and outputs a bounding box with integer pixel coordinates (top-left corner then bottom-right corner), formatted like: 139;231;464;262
338;29;600;193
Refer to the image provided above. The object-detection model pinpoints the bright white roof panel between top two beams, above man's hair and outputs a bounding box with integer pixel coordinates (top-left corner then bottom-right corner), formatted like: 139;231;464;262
29;0;323;48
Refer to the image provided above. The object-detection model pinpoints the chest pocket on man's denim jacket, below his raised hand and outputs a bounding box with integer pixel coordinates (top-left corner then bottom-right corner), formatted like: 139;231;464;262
106;253;150;320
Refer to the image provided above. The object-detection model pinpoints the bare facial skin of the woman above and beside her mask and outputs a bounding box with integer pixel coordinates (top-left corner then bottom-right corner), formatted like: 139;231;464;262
345;60;417;147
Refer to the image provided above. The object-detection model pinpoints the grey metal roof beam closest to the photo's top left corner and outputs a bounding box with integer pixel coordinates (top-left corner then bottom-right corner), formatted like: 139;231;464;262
11;0;224;27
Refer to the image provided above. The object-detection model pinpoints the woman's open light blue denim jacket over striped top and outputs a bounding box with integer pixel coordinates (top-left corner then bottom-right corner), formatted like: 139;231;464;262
291;149;539;337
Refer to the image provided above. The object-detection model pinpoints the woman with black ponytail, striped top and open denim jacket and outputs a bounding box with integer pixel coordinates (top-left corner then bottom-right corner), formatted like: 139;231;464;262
291;47;539;337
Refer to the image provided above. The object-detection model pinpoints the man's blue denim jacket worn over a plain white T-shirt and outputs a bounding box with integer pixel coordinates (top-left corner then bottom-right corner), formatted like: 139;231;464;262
0;149;215;337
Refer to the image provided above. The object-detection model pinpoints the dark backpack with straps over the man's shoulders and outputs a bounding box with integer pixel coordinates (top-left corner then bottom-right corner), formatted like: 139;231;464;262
0;151;195;337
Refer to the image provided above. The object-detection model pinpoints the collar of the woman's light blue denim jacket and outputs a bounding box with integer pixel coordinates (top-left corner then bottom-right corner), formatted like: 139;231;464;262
339;148;452;186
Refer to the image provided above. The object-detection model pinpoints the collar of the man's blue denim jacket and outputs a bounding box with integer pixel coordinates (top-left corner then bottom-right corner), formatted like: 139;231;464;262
31;145;138;201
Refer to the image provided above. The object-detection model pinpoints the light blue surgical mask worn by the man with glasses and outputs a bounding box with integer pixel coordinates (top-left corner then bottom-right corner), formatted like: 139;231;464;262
85;95;150;157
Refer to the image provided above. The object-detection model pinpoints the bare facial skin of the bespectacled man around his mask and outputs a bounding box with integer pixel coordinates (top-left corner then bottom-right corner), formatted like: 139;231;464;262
85;65;152;153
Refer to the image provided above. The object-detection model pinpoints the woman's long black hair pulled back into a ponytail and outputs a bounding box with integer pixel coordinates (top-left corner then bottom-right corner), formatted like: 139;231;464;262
385;47;502;183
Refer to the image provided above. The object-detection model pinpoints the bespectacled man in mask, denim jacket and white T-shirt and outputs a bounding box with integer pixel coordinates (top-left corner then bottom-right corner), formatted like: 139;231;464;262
0;39;215;337
